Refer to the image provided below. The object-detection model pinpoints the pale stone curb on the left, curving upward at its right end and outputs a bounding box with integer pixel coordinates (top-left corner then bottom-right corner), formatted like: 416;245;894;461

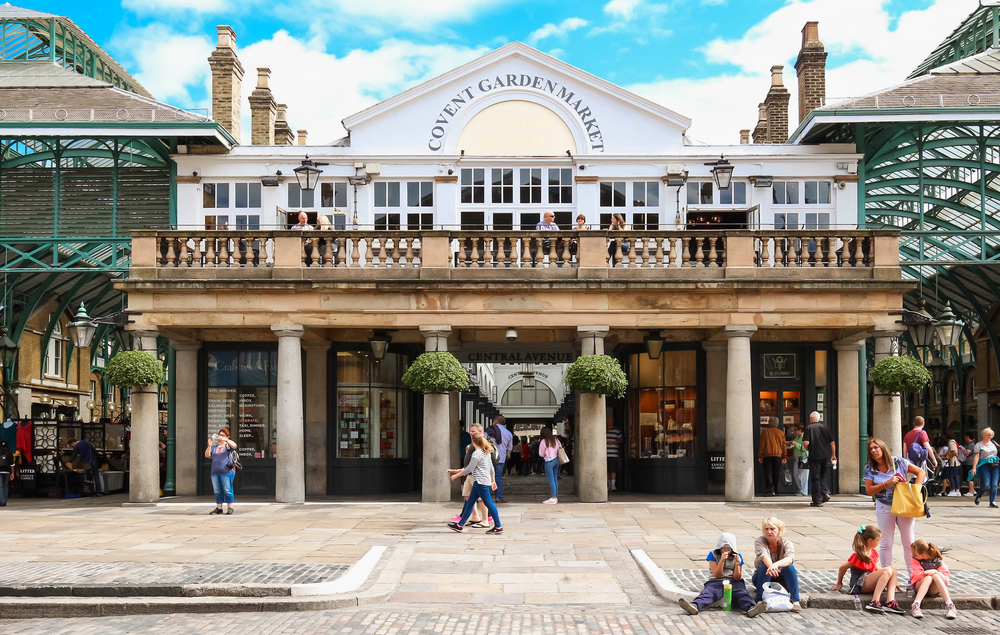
0;546;402;619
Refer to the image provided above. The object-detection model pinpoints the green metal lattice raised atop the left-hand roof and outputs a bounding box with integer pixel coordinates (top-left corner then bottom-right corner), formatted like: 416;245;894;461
0;14;152;97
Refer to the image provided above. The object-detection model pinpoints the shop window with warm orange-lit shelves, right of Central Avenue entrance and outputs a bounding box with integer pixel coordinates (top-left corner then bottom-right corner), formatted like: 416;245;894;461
629;351;698;459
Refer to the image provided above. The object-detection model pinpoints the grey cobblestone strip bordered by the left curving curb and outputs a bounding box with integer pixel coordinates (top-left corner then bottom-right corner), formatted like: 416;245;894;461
0;562;349;585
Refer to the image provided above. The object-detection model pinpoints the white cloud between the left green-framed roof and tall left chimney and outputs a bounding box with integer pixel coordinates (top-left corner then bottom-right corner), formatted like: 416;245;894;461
110;23;215;108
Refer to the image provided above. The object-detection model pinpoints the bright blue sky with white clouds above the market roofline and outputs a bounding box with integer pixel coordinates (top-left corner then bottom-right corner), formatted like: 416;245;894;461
29;0;978;143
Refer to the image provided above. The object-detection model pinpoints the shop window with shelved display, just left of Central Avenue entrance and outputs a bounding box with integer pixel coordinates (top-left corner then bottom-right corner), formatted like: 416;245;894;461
336;351;409;459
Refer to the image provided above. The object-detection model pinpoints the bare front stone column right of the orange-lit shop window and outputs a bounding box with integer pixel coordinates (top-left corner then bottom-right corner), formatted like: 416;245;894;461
725;326;757;501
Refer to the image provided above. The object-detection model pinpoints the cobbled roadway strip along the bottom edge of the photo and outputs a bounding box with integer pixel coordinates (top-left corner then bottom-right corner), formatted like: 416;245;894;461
0;603;1000;635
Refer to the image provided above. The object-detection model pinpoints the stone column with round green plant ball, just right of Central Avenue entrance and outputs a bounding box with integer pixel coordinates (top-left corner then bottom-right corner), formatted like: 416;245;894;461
566;355;628;503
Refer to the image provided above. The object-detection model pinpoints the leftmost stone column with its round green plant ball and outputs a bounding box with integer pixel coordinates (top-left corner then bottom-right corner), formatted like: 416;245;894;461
104;340;163;505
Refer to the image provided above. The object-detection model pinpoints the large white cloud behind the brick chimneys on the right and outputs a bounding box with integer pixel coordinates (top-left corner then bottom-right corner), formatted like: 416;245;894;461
626;0;964;143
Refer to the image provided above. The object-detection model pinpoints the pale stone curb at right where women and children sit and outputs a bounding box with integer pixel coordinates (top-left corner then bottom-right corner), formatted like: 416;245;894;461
631;549;1000;611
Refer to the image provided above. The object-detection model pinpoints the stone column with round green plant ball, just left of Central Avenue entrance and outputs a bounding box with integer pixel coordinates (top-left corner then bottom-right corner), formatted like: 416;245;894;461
403;352;469;502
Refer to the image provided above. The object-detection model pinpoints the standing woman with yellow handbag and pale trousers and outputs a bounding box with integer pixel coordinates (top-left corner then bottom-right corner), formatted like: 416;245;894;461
865;438;926;574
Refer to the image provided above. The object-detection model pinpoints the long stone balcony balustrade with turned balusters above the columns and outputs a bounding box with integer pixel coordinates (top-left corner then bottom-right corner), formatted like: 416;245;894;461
131;230;899;280
